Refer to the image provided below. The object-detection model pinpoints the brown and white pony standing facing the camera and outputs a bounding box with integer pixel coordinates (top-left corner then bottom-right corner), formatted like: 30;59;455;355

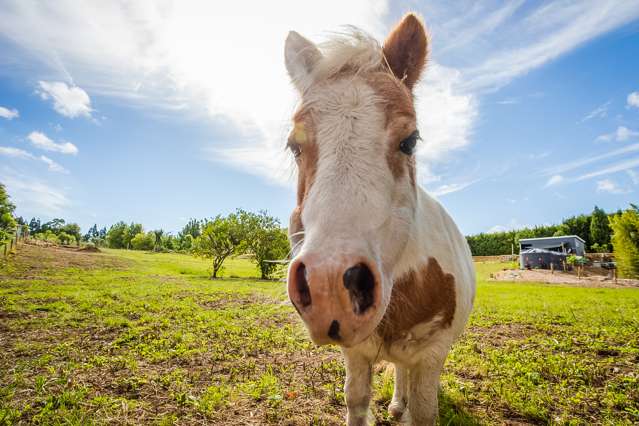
285;14;475;425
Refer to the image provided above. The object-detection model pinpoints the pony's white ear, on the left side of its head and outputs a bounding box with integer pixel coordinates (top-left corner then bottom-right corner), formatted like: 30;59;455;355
284;31;322;92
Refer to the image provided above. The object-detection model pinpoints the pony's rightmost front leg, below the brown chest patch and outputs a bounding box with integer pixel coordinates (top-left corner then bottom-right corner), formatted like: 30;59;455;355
408;360;444;426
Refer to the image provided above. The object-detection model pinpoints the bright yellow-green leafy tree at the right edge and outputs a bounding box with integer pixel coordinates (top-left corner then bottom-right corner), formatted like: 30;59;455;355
610;208;639;278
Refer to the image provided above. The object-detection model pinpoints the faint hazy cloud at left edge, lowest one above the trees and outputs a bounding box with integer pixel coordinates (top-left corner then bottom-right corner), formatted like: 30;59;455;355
0;171;71;216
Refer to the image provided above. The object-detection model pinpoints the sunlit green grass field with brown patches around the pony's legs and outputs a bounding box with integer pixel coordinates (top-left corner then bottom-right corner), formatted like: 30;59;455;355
0;245;639;425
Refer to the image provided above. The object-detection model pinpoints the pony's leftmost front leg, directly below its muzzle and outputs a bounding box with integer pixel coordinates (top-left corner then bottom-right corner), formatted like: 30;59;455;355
342;349;372;426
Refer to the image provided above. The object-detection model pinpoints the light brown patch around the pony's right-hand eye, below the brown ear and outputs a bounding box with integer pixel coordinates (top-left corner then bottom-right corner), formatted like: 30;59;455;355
366;72;416;186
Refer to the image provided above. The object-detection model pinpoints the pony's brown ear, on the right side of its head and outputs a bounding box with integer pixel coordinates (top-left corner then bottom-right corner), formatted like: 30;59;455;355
383;13;428;89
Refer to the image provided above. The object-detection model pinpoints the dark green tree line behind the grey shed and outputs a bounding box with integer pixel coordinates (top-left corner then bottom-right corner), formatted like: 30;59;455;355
466;206;623;256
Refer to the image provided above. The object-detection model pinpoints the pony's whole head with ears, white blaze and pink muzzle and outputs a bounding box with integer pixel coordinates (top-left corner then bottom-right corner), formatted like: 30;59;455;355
285;14;428;346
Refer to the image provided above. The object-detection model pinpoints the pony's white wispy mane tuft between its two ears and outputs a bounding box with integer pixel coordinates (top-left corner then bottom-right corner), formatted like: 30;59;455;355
312;26;388;82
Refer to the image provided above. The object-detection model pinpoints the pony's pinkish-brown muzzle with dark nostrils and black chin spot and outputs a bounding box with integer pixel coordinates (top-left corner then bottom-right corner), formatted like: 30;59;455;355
288;254;381;346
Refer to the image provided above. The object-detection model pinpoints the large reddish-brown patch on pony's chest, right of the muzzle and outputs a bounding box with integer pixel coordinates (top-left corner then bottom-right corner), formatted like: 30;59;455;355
377;257;456;343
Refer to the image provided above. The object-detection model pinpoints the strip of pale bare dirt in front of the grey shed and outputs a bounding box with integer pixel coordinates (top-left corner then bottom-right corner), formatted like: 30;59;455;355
491;269;639;288
